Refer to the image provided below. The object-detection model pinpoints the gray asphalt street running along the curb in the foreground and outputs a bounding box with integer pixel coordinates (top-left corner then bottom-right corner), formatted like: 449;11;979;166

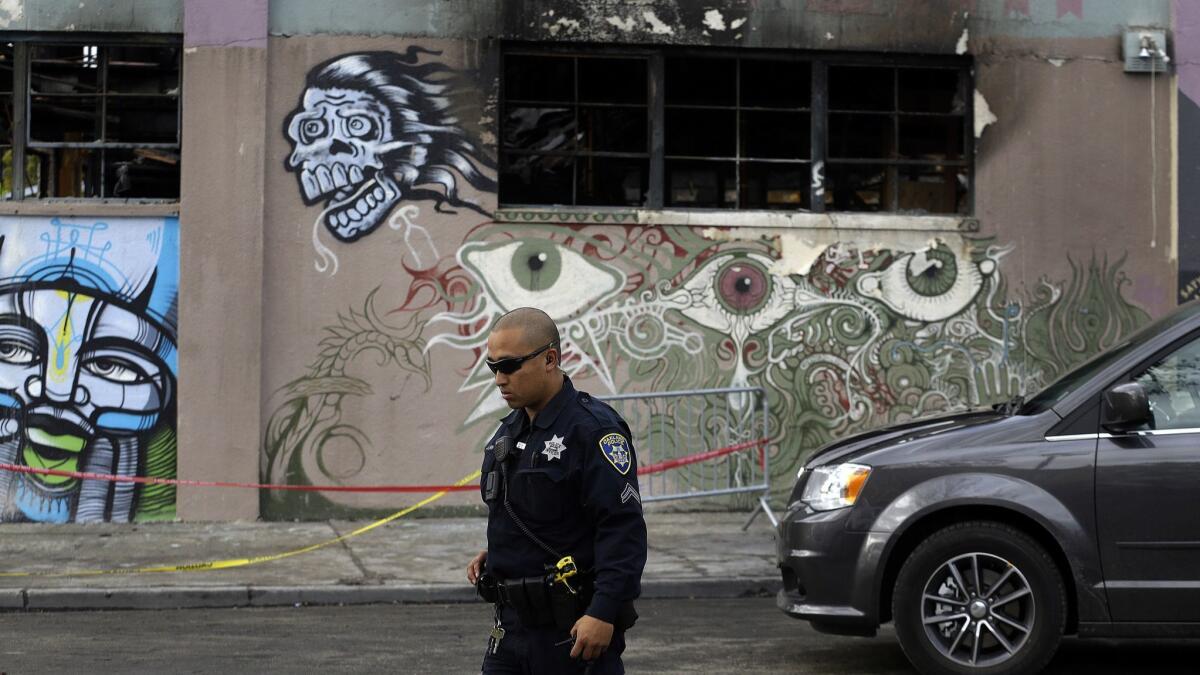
0;598;1200;675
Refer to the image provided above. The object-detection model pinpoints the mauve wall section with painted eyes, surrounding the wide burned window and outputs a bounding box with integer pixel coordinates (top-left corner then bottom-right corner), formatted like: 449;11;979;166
253;0;1176;518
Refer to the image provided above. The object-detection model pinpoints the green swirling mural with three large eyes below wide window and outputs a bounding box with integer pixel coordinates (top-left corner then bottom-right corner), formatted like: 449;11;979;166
265;222;1148;511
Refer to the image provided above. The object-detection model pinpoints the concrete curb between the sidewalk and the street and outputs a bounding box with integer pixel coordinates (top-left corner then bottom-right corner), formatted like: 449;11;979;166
0;578;780;611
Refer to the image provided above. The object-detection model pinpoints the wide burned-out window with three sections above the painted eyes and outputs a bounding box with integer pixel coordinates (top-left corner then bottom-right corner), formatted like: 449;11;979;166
500;49;973;214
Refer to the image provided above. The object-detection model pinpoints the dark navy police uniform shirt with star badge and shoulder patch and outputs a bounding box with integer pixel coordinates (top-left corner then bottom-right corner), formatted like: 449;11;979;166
484;375;646;623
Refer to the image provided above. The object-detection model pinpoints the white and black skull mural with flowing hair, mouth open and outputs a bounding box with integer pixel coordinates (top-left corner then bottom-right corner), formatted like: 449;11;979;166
283;46;496;271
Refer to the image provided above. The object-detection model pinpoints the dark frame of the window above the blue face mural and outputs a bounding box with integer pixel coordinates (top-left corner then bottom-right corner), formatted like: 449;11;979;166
0;31;184;199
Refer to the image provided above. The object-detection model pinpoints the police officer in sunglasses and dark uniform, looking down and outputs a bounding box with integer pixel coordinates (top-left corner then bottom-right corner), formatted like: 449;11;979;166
467;307;646;675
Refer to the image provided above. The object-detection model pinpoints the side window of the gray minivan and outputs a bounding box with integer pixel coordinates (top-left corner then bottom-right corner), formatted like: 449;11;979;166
1133;339;1200;430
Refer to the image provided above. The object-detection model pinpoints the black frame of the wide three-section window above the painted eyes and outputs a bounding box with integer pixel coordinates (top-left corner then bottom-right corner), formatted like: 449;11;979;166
496;42;976;212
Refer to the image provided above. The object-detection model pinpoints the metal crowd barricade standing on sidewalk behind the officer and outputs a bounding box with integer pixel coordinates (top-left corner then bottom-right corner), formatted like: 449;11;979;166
598;387;779;530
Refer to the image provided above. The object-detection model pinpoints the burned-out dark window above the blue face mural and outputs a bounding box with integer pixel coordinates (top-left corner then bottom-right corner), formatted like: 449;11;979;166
0;40;180;199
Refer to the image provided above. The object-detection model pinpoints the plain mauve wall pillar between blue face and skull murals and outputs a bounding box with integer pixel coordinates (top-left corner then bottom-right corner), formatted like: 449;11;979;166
179;0;267;520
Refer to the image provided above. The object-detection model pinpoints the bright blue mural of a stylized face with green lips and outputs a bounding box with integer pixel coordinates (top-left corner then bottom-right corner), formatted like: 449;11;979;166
0;217;179;522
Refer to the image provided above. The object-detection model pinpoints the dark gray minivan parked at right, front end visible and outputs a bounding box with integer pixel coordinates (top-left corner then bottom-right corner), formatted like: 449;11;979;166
776;304;1200;675
